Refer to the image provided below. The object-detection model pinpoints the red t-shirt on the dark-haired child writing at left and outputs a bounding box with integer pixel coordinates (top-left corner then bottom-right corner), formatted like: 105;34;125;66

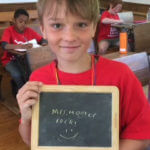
1;26;42;66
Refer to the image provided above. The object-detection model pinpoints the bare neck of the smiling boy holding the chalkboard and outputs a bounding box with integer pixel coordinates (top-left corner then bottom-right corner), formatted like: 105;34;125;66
58;54;91;73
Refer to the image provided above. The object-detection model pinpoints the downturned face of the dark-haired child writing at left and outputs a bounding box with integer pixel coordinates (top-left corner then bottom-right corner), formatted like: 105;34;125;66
15;15;29;33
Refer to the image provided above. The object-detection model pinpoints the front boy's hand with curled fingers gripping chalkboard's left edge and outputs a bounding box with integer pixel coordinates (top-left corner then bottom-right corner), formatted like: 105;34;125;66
17;81;42;124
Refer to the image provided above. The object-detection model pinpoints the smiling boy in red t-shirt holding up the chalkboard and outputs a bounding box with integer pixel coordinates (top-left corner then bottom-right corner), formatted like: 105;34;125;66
17;0;150;150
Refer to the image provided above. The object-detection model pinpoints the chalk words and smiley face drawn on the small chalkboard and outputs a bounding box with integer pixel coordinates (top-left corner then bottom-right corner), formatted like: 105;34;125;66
50;108;96;140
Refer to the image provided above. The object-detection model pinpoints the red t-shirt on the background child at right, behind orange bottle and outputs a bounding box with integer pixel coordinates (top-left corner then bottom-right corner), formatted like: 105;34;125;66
97;11;119;42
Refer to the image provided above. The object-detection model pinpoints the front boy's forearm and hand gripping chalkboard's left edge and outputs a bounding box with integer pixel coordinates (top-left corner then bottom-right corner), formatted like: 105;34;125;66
17;82;42;145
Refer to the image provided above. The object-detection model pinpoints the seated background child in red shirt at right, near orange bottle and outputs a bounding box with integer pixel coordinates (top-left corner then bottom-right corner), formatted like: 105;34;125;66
97;0;123;54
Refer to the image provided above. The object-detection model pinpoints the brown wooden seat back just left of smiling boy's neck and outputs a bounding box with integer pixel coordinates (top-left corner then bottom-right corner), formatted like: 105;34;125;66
27;46;55;72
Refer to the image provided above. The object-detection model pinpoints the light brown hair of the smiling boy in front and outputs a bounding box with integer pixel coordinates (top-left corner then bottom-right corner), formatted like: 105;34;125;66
37;0;99;24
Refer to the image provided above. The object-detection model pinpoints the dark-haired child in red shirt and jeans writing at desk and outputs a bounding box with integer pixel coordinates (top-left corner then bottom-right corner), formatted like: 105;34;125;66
1;9;46;89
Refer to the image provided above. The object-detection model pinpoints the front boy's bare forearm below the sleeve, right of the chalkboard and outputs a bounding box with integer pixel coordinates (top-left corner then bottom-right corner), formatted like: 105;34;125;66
119;139;150;150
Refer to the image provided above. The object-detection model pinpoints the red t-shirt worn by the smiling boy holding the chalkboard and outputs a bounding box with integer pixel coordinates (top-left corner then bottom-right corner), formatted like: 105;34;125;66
30;57;150;139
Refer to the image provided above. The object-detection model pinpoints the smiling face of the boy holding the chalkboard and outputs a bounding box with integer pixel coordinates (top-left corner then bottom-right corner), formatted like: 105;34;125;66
41;3;96;61
